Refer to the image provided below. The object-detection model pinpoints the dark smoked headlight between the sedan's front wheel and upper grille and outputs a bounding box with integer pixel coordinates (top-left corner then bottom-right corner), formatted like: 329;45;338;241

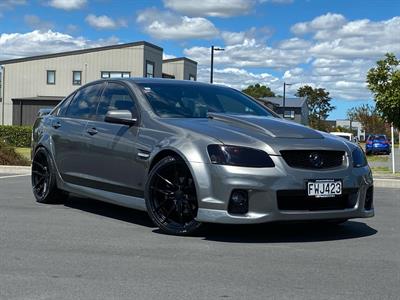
207;145;275;168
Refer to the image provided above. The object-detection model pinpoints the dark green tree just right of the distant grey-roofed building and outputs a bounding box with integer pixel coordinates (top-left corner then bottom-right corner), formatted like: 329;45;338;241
296;85;335;130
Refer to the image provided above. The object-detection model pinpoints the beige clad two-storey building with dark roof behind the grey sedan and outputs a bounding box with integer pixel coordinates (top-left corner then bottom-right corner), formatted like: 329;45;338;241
0;41;197;125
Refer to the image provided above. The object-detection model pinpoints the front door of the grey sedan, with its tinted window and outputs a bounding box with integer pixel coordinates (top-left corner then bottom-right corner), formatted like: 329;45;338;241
85;82;145;197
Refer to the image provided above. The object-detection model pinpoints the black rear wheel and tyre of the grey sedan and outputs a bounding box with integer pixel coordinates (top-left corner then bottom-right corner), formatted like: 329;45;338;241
31;147;68;204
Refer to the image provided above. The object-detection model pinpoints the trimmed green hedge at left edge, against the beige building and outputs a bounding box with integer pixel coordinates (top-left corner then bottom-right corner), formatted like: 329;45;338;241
0;125;32;147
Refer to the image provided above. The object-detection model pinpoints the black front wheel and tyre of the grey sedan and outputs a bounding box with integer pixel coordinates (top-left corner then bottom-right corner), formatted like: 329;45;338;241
145;156;202;235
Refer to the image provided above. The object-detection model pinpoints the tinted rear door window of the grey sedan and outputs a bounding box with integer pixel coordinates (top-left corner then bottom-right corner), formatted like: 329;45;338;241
66;83;103;119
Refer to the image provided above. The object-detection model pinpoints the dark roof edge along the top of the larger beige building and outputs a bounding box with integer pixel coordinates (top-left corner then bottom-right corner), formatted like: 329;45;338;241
0;41;163;65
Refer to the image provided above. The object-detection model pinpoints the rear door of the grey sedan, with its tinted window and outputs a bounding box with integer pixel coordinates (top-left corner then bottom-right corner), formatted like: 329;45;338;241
51;83;104;183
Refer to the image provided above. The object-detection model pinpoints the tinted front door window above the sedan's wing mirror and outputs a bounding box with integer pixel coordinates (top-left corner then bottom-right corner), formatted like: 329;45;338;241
96;83;136;120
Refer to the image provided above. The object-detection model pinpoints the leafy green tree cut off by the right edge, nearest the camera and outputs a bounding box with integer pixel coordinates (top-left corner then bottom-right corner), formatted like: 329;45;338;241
367;53;400;128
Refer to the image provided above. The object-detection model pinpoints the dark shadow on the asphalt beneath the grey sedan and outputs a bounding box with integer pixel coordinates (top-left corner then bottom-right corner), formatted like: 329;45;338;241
63;197;378;243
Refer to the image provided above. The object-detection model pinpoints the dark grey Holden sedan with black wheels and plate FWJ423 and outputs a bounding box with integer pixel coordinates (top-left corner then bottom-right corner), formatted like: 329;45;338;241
32;78;374;235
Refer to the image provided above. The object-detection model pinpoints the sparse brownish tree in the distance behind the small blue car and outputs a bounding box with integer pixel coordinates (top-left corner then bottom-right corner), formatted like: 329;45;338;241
347;104;387;134
